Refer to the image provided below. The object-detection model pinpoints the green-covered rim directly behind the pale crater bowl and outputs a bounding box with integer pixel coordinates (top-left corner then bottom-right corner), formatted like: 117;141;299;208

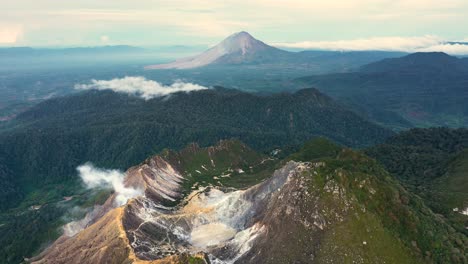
162;140;279;192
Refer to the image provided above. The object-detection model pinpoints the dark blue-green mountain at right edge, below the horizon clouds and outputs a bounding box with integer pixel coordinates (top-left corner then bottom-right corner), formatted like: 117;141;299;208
300;52;468;129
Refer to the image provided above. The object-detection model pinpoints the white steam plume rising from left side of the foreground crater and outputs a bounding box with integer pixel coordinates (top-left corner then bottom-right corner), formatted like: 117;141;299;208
76;163;143;206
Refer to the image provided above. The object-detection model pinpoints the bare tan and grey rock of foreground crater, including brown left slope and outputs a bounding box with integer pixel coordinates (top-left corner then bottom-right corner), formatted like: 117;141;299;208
33;152;305;264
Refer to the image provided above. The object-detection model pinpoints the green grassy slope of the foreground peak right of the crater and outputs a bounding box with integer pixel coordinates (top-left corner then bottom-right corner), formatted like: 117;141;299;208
290;139;468;263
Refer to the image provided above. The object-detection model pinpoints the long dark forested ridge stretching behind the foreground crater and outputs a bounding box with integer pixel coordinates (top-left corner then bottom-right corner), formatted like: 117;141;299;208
0;88;392;210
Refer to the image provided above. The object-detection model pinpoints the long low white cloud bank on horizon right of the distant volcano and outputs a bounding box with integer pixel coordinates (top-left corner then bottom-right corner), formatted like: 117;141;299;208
274;36;468;55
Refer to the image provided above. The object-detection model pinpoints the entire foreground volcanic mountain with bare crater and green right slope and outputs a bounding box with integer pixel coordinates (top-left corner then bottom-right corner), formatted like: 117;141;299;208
31;139;468;264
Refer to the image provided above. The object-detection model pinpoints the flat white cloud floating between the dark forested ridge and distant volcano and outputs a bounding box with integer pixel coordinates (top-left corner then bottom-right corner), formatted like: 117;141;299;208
75;77;208;100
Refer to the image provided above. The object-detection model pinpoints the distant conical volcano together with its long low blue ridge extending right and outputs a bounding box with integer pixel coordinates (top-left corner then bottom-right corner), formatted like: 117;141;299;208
146;31;403;72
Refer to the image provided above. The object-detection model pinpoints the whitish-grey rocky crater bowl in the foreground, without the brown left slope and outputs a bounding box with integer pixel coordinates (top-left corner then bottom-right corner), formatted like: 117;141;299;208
123;162;308;263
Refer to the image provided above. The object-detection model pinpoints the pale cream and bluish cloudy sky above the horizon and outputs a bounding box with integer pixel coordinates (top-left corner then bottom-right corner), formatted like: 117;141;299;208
0;0;468;49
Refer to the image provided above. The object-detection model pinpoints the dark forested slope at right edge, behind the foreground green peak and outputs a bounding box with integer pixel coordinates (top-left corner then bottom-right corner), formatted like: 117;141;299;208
366;128;468;232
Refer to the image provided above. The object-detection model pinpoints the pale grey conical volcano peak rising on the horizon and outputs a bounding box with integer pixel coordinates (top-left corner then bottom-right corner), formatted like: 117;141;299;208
146;31;290;69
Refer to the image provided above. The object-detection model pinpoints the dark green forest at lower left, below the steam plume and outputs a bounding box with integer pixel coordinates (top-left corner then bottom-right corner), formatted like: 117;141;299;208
0;180;115;263
